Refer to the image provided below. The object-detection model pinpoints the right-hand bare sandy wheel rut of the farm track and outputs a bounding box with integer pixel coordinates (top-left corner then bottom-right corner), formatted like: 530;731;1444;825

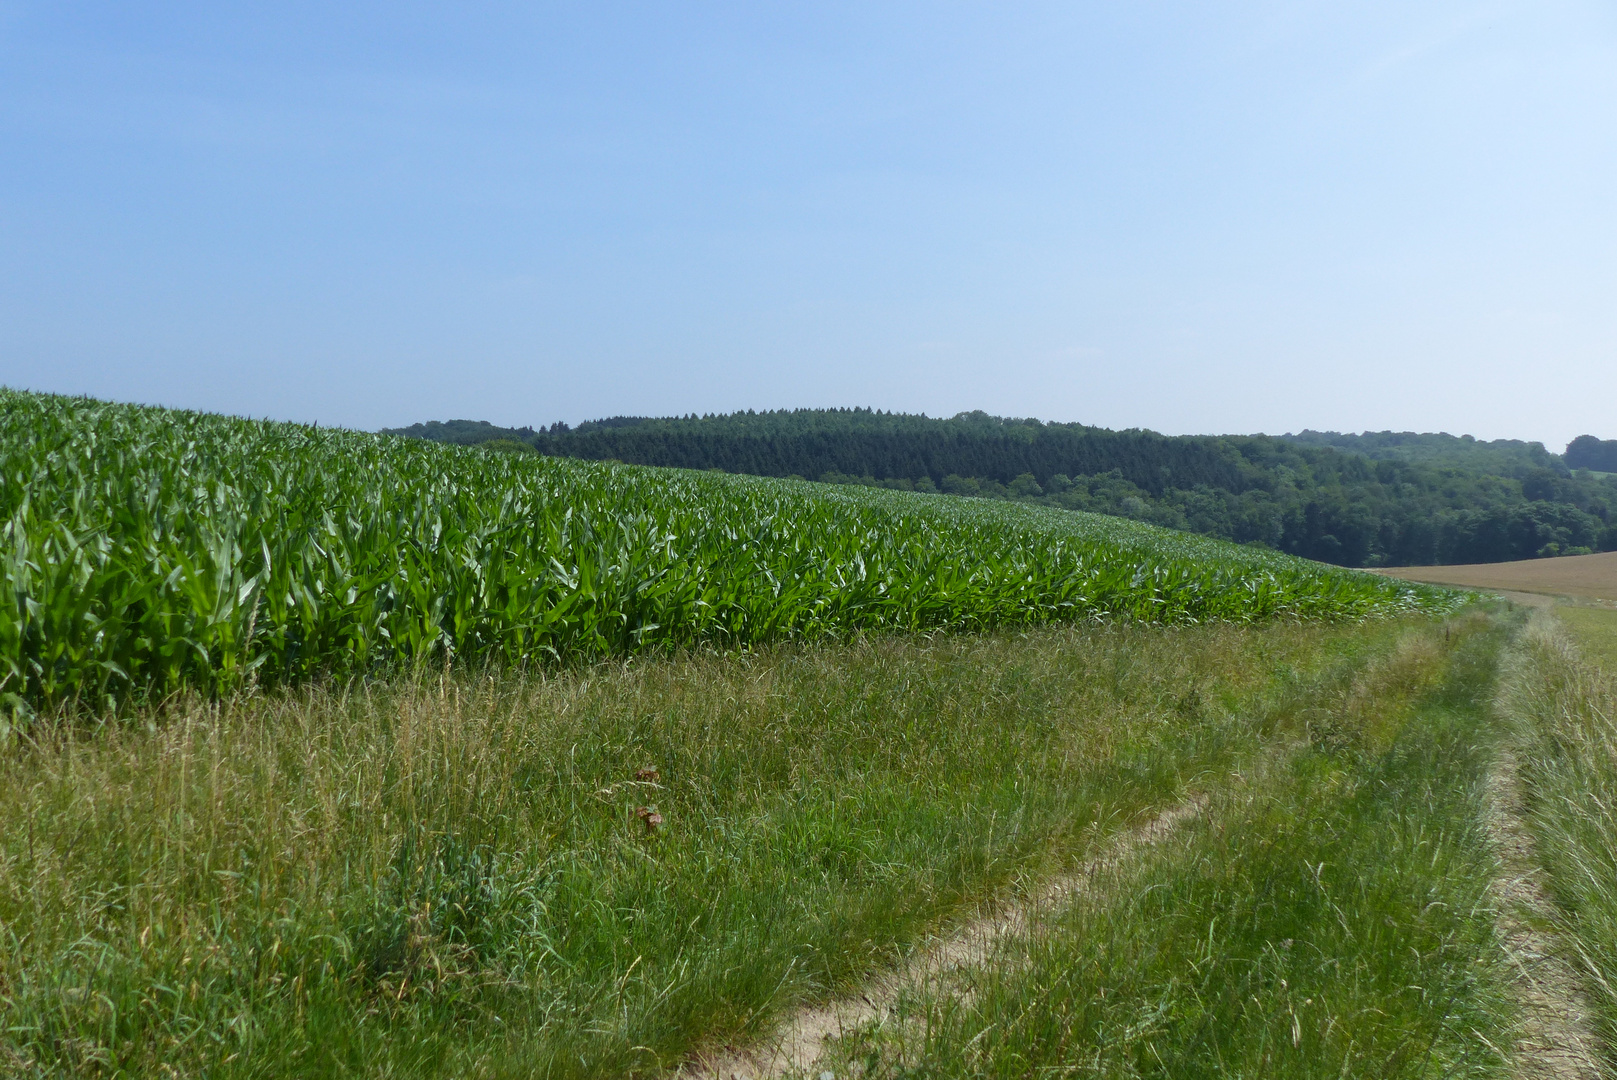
1488;749;1606;1080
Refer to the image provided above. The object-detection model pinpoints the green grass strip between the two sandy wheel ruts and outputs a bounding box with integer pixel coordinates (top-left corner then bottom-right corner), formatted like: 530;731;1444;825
828;619;1514;1080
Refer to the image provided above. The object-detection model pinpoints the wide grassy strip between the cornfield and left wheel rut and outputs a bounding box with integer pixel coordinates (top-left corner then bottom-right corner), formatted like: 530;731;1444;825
0;622;1399;1078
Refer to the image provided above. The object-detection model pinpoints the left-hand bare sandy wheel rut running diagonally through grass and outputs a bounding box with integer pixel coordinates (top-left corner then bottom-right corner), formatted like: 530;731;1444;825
678;797;1206;1080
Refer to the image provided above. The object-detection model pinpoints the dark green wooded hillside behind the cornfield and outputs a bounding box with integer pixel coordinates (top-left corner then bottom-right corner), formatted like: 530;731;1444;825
386;409;1617;566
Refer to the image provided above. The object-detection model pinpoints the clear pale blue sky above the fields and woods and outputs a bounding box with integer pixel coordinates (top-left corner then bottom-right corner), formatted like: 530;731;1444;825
0;0;1617;449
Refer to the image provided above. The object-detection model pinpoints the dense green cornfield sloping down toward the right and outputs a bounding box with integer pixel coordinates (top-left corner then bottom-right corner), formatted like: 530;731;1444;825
0;390;1452;713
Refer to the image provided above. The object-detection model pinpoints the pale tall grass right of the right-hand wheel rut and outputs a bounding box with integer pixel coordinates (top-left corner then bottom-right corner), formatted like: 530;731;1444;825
1499;613;1617;1067
